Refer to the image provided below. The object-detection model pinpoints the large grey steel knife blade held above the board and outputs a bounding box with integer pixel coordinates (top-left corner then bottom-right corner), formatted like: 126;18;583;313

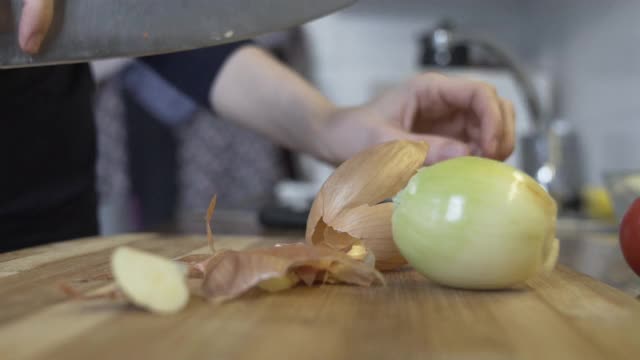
0;0;355;68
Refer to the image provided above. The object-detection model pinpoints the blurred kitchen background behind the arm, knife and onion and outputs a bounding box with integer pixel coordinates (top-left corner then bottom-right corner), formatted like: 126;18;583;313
89;0;640;292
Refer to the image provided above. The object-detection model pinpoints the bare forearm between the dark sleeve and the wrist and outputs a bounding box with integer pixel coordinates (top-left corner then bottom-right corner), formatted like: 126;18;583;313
210;46;335;160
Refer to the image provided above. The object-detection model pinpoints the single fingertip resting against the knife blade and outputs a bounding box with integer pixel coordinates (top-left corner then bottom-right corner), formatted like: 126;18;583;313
18;0;54;54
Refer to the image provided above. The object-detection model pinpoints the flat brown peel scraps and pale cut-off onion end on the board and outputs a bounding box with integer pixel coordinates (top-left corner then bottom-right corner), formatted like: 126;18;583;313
61;196;384;313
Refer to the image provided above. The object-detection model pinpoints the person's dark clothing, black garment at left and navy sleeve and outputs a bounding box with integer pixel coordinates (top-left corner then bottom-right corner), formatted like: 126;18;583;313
0;42;249;252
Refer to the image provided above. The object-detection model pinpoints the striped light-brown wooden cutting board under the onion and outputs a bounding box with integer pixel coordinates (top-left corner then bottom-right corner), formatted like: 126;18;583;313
0;234;640;360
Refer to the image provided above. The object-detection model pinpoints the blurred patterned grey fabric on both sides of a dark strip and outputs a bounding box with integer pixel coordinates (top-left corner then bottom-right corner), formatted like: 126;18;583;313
95;76;286;233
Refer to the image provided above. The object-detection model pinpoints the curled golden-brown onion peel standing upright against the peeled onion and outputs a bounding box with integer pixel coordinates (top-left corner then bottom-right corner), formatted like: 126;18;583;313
305;141;429;270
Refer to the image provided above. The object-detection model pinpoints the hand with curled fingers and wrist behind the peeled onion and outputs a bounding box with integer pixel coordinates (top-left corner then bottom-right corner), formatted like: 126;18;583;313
321;73;515;164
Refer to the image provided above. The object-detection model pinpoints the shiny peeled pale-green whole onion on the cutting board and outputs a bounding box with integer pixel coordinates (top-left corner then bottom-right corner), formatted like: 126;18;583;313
392;157;558;289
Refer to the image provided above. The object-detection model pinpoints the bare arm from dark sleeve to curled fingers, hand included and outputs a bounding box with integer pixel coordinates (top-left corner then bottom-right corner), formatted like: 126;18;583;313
210;46;514;163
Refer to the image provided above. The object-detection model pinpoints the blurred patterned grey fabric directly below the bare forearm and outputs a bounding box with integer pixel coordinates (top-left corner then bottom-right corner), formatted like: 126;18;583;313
179;107;285;213
